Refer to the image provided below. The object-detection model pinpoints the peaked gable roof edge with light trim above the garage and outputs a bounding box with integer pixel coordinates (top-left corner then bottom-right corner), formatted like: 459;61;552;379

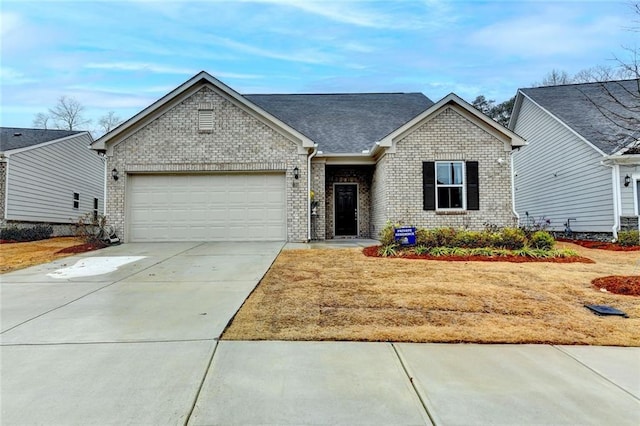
92;71;313;150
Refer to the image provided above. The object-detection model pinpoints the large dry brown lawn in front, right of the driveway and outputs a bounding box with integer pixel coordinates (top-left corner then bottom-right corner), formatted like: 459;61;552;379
223;243;640;346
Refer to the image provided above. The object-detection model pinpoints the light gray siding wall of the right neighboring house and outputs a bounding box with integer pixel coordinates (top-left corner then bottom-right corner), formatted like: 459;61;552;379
513;98;614;232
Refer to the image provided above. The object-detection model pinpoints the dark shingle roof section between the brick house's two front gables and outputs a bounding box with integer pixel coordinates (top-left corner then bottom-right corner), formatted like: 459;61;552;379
244;93;433;154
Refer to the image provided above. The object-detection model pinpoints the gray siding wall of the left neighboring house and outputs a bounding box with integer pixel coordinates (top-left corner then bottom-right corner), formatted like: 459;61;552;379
6;134;104;223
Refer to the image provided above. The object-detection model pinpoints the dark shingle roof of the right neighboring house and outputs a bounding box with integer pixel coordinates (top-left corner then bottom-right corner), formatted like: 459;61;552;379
510;79;640;154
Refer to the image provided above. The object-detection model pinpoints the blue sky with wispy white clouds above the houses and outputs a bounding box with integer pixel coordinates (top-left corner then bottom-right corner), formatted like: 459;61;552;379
0;0;640;129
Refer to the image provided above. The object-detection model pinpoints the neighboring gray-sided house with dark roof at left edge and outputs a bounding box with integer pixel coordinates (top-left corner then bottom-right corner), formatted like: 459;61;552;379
0;127;105;235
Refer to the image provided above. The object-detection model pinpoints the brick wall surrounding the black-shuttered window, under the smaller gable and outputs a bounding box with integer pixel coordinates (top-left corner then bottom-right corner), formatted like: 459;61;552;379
371;108;515;236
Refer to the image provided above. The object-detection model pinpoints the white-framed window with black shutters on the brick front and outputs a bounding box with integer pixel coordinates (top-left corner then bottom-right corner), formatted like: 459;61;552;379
422;161;480;212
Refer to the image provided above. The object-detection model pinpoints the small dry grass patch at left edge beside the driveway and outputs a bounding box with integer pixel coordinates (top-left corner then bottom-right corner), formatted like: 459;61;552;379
0;237;84;273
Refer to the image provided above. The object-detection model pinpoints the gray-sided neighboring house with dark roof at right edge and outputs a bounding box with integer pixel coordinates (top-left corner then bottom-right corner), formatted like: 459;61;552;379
509;79;640;238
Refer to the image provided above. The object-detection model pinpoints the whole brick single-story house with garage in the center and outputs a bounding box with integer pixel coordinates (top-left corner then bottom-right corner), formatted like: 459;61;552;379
93;72;524;241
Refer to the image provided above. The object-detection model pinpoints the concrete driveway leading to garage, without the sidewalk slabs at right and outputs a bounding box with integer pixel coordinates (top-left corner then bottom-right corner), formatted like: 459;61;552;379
0;242;284;425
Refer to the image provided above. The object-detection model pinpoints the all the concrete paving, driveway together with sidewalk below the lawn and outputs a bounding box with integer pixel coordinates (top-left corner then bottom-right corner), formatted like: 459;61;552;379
0;243;640;426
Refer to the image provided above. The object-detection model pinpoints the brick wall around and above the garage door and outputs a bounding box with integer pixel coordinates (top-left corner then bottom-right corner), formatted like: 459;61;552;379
107;86;307;241
